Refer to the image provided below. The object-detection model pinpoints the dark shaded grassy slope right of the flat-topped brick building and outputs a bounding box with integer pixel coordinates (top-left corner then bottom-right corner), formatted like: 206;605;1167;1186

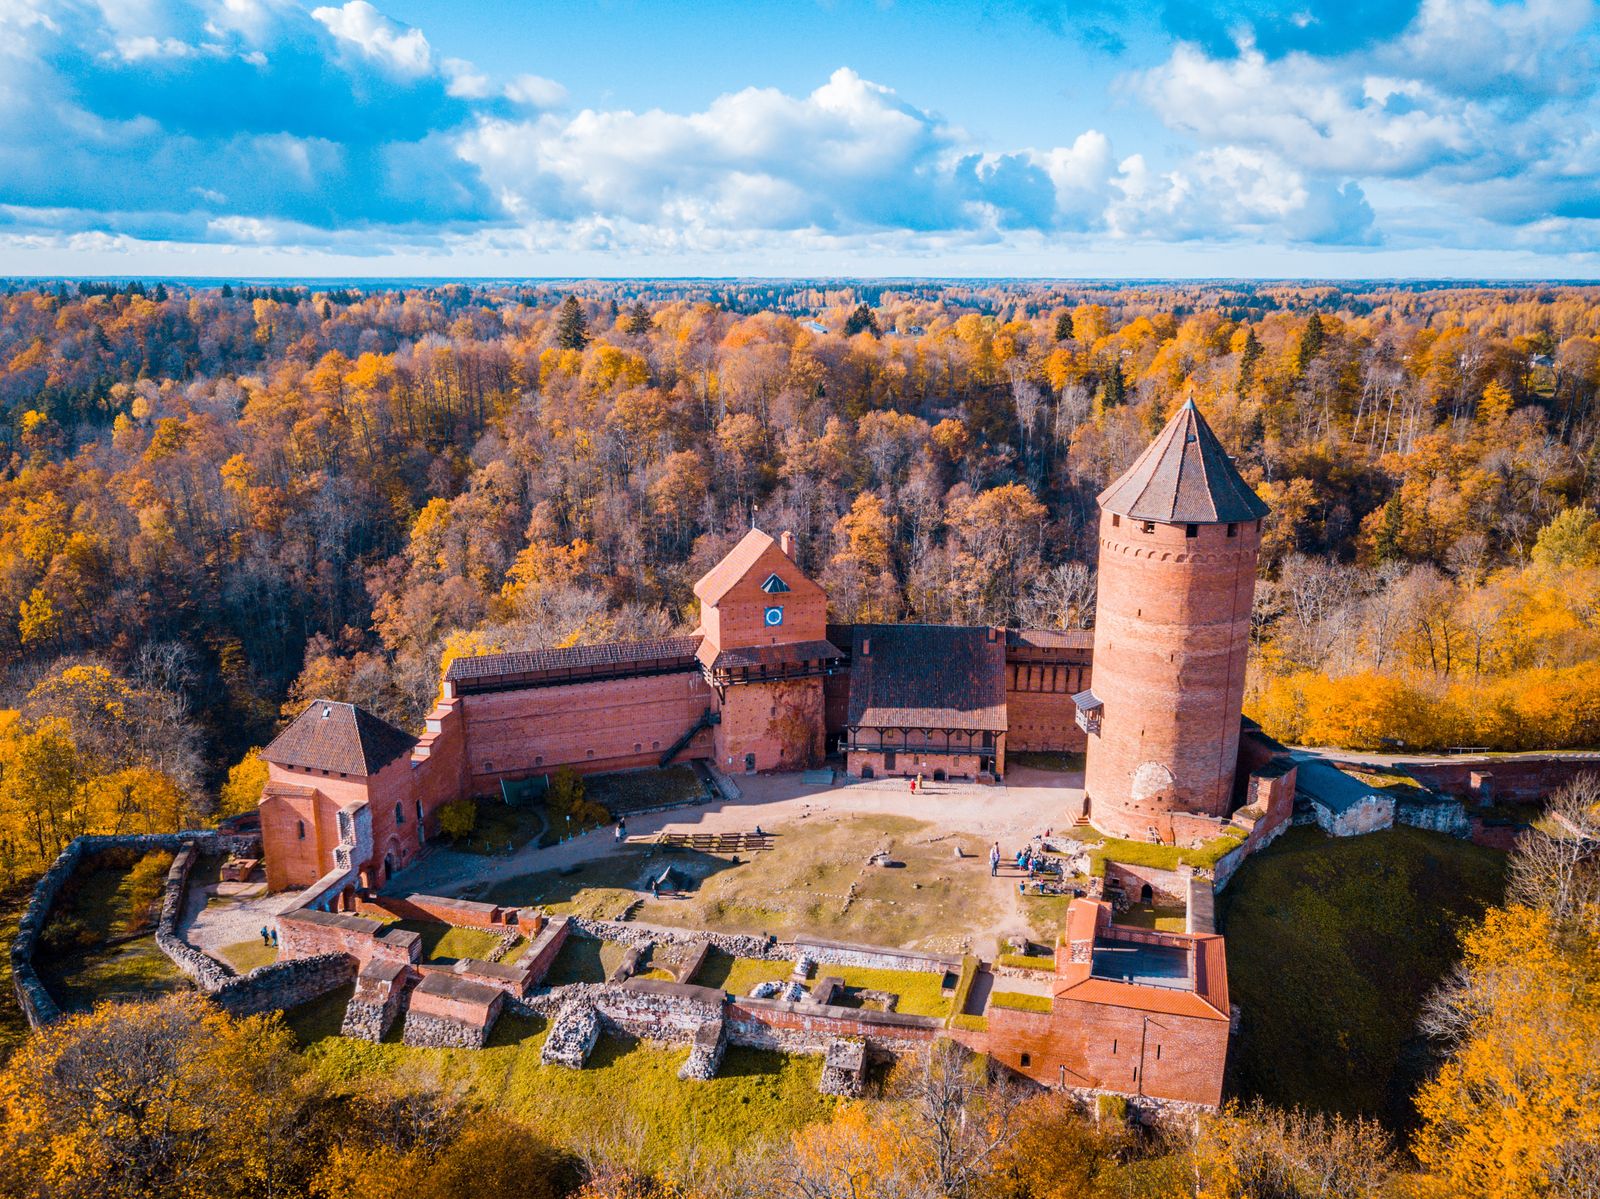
1219;826;1504;1130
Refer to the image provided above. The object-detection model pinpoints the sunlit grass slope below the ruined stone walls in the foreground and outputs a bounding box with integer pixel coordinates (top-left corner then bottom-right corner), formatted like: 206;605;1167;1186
288;988;835;1165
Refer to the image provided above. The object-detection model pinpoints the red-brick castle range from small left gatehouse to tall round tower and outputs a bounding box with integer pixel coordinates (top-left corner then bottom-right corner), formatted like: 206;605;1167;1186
259;402;1267;904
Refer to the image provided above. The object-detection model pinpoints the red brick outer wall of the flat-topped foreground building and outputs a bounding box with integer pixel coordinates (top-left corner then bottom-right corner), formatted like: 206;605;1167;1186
962;999;1227;1106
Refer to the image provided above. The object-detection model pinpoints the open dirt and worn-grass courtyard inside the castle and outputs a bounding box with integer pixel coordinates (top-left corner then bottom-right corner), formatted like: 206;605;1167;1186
389;768;1082;954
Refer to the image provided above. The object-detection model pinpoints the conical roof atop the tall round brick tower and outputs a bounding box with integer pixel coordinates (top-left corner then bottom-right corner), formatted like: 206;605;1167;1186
1099;400;1270;525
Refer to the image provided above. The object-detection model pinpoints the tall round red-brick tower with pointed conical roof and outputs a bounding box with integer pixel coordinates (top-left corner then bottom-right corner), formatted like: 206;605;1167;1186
1075;402;1267;842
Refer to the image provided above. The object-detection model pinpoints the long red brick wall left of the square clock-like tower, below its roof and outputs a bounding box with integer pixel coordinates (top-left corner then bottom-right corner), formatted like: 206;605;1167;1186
459;671;717;794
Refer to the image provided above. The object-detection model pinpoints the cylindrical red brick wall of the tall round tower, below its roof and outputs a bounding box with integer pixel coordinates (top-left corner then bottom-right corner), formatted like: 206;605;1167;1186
1085;512;1259;837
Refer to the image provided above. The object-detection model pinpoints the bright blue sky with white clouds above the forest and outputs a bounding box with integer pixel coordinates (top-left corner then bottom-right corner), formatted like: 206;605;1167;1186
0;0;1600;279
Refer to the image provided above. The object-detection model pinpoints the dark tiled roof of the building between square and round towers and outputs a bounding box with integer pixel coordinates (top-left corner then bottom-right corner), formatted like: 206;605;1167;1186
848;624;1006;733
